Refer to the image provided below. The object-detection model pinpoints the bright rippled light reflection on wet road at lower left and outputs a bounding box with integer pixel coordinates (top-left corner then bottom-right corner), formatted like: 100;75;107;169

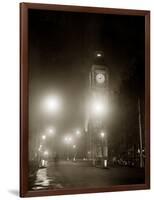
32;168;63;190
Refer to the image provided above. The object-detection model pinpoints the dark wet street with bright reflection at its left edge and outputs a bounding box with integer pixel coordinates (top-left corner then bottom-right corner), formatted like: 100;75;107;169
29;161;144;190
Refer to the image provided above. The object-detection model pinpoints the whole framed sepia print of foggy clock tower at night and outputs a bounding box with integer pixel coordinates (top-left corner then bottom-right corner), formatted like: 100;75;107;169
20;3;150;197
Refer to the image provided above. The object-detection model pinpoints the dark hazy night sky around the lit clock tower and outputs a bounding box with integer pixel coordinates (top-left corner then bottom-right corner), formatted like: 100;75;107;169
29;10;145;156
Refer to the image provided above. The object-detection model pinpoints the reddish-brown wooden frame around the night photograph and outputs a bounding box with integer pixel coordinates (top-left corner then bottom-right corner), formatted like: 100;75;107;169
20;3;150;197
